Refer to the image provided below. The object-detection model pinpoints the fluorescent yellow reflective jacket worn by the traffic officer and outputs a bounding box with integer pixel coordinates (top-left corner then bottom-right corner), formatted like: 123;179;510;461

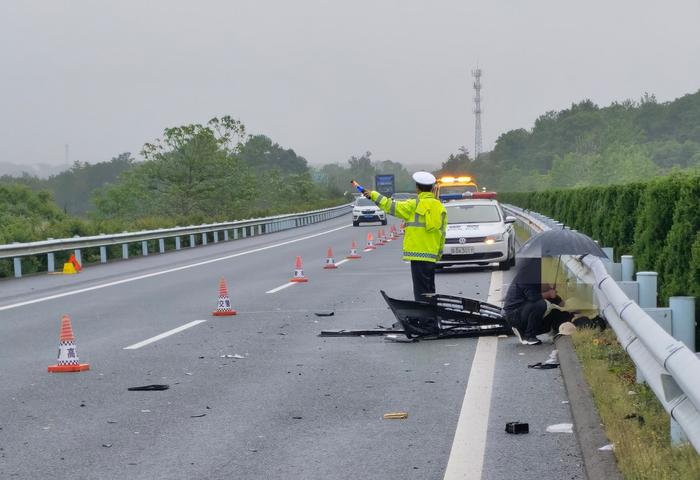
370;191;447;262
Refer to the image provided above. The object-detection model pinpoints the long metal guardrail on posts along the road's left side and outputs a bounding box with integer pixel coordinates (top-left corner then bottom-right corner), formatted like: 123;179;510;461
0;204;352;278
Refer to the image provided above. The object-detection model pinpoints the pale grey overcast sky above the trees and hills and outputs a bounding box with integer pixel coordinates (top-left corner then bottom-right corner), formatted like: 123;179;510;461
0;0;700;170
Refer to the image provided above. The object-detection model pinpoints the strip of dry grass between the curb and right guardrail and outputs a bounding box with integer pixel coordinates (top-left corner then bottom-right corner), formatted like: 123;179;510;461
573;329;700;480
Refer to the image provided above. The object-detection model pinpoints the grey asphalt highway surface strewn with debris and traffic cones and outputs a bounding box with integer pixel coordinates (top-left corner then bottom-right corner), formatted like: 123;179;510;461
0;215;585;479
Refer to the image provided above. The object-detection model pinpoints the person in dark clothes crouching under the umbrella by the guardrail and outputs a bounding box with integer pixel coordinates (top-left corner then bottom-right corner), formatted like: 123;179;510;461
503;259;574;345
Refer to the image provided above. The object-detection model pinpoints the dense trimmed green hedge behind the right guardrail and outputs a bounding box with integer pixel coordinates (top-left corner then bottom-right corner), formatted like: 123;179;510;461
499;173;700;342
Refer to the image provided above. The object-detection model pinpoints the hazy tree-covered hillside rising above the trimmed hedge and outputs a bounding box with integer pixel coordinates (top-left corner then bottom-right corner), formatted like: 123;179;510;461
440;90;700;192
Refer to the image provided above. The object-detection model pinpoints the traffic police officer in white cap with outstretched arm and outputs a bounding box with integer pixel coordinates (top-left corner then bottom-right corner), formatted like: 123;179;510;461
363;172;447;301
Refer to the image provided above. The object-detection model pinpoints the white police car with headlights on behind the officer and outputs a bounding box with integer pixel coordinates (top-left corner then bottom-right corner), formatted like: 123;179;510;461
437;195;515;270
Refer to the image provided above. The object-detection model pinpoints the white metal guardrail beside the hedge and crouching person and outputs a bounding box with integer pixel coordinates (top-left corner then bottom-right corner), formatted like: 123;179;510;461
504;205;700;452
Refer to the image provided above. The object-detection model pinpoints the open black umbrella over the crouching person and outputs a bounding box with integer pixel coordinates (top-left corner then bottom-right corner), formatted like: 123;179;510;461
518;229;607;258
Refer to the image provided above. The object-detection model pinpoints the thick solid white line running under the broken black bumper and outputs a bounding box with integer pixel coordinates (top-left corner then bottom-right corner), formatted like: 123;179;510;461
444;270;503;480
